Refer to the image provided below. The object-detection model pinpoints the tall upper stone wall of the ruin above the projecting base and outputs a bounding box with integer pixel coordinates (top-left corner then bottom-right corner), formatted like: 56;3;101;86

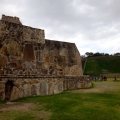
0;20;83;75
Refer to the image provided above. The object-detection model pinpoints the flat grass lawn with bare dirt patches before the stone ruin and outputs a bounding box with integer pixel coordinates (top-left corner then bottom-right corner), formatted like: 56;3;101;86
0;79;120;120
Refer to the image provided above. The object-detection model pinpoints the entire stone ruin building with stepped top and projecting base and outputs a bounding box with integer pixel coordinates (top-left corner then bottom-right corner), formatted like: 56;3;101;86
0;15;91;100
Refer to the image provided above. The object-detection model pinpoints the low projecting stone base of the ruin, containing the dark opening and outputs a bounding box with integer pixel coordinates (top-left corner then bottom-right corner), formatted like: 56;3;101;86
0;76;92;101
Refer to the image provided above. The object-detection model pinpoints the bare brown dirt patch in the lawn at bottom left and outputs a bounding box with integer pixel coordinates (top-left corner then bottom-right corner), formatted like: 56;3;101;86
0;102;52;120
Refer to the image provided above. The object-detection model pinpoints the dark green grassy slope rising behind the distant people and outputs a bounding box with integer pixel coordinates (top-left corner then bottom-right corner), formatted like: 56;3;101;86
84;56;120;76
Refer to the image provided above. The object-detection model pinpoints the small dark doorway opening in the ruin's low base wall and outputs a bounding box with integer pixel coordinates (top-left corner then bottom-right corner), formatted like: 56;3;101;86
5;80;13;101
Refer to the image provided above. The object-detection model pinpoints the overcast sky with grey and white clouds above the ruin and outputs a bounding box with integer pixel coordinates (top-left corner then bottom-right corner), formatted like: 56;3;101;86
0;0;120;55
